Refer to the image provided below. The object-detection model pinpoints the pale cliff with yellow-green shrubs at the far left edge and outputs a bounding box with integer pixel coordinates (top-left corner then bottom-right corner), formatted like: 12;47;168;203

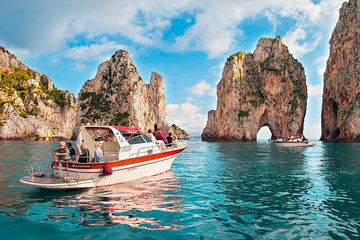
0;47;76;139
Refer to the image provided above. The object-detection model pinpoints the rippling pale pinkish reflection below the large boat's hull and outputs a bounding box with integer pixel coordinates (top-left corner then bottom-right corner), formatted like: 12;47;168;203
47;171;182;230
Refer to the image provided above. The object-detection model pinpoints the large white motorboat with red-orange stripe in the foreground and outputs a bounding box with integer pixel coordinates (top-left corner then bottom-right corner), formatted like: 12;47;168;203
20;126;187;189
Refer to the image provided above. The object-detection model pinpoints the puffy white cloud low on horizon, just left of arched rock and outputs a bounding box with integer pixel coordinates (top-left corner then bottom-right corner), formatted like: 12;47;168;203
166;103;207;134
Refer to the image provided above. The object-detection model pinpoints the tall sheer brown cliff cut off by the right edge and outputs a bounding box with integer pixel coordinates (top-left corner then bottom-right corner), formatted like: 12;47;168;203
320;0;360;141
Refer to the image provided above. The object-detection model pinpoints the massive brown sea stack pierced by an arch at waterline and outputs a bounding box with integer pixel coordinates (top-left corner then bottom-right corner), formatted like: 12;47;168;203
202;36;307;141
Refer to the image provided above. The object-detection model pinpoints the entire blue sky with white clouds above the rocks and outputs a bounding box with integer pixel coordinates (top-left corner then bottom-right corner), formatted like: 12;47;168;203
0;0;343;139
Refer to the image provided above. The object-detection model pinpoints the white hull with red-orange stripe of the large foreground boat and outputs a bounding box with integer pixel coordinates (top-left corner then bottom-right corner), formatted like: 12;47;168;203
20;148;185;189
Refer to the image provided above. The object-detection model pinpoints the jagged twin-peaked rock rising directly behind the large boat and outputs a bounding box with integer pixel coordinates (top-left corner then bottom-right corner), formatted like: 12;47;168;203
78;50;190;136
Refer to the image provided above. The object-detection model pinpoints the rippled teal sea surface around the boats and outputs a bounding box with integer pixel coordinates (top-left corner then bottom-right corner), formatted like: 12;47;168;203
0;140;360;240
